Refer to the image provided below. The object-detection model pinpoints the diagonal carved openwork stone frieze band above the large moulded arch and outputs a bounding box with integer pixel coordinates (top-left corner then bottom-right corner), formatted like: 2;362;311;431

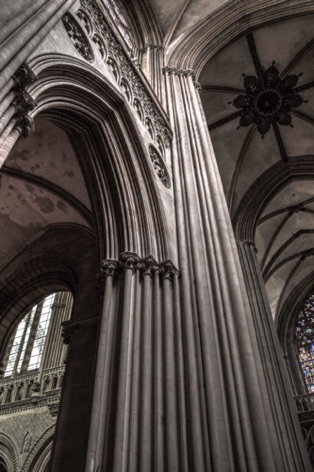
77;0;172;148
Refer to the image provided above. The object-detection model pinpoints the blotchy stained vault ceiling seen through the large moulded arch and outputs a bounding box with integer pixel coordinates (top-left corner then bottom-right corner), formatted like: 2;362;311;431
0;118;92;271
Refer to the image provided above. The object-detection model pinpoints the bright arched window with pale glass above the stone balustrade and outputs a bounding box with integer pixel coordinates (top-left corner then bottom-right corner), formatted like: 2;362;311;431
3;292;72;377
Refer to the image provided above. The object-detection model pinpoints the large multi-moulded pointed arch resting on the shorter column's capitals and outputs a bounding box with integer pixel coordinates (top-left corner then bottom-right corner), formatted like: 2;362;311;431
25;55;171;260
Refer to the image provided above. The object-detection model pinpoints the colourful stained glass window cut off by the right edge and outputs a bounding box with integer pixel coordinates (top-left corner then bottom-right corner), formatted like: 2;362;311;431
296;294;314;392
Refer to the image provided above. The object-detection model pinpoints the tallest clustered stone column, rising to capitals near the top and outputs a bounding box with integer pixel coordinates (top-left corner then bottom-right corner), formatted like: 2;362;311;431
164;67;310;472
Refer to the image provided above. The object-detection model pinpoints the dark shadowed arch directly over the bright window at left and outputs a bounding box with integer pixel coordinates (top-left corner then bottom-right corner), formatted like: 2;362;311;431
0;224;97;354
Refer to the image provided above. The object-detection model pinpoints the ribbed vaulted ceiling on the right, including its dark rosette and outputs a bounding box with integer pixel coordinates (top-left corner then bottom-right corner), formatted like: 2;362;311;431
199;16;314;316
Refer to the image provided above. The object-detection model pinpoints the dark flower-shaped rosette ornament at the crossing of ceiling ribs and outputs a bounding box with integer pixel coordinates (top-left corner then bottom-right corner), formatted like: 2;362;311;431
233;61;307;138
